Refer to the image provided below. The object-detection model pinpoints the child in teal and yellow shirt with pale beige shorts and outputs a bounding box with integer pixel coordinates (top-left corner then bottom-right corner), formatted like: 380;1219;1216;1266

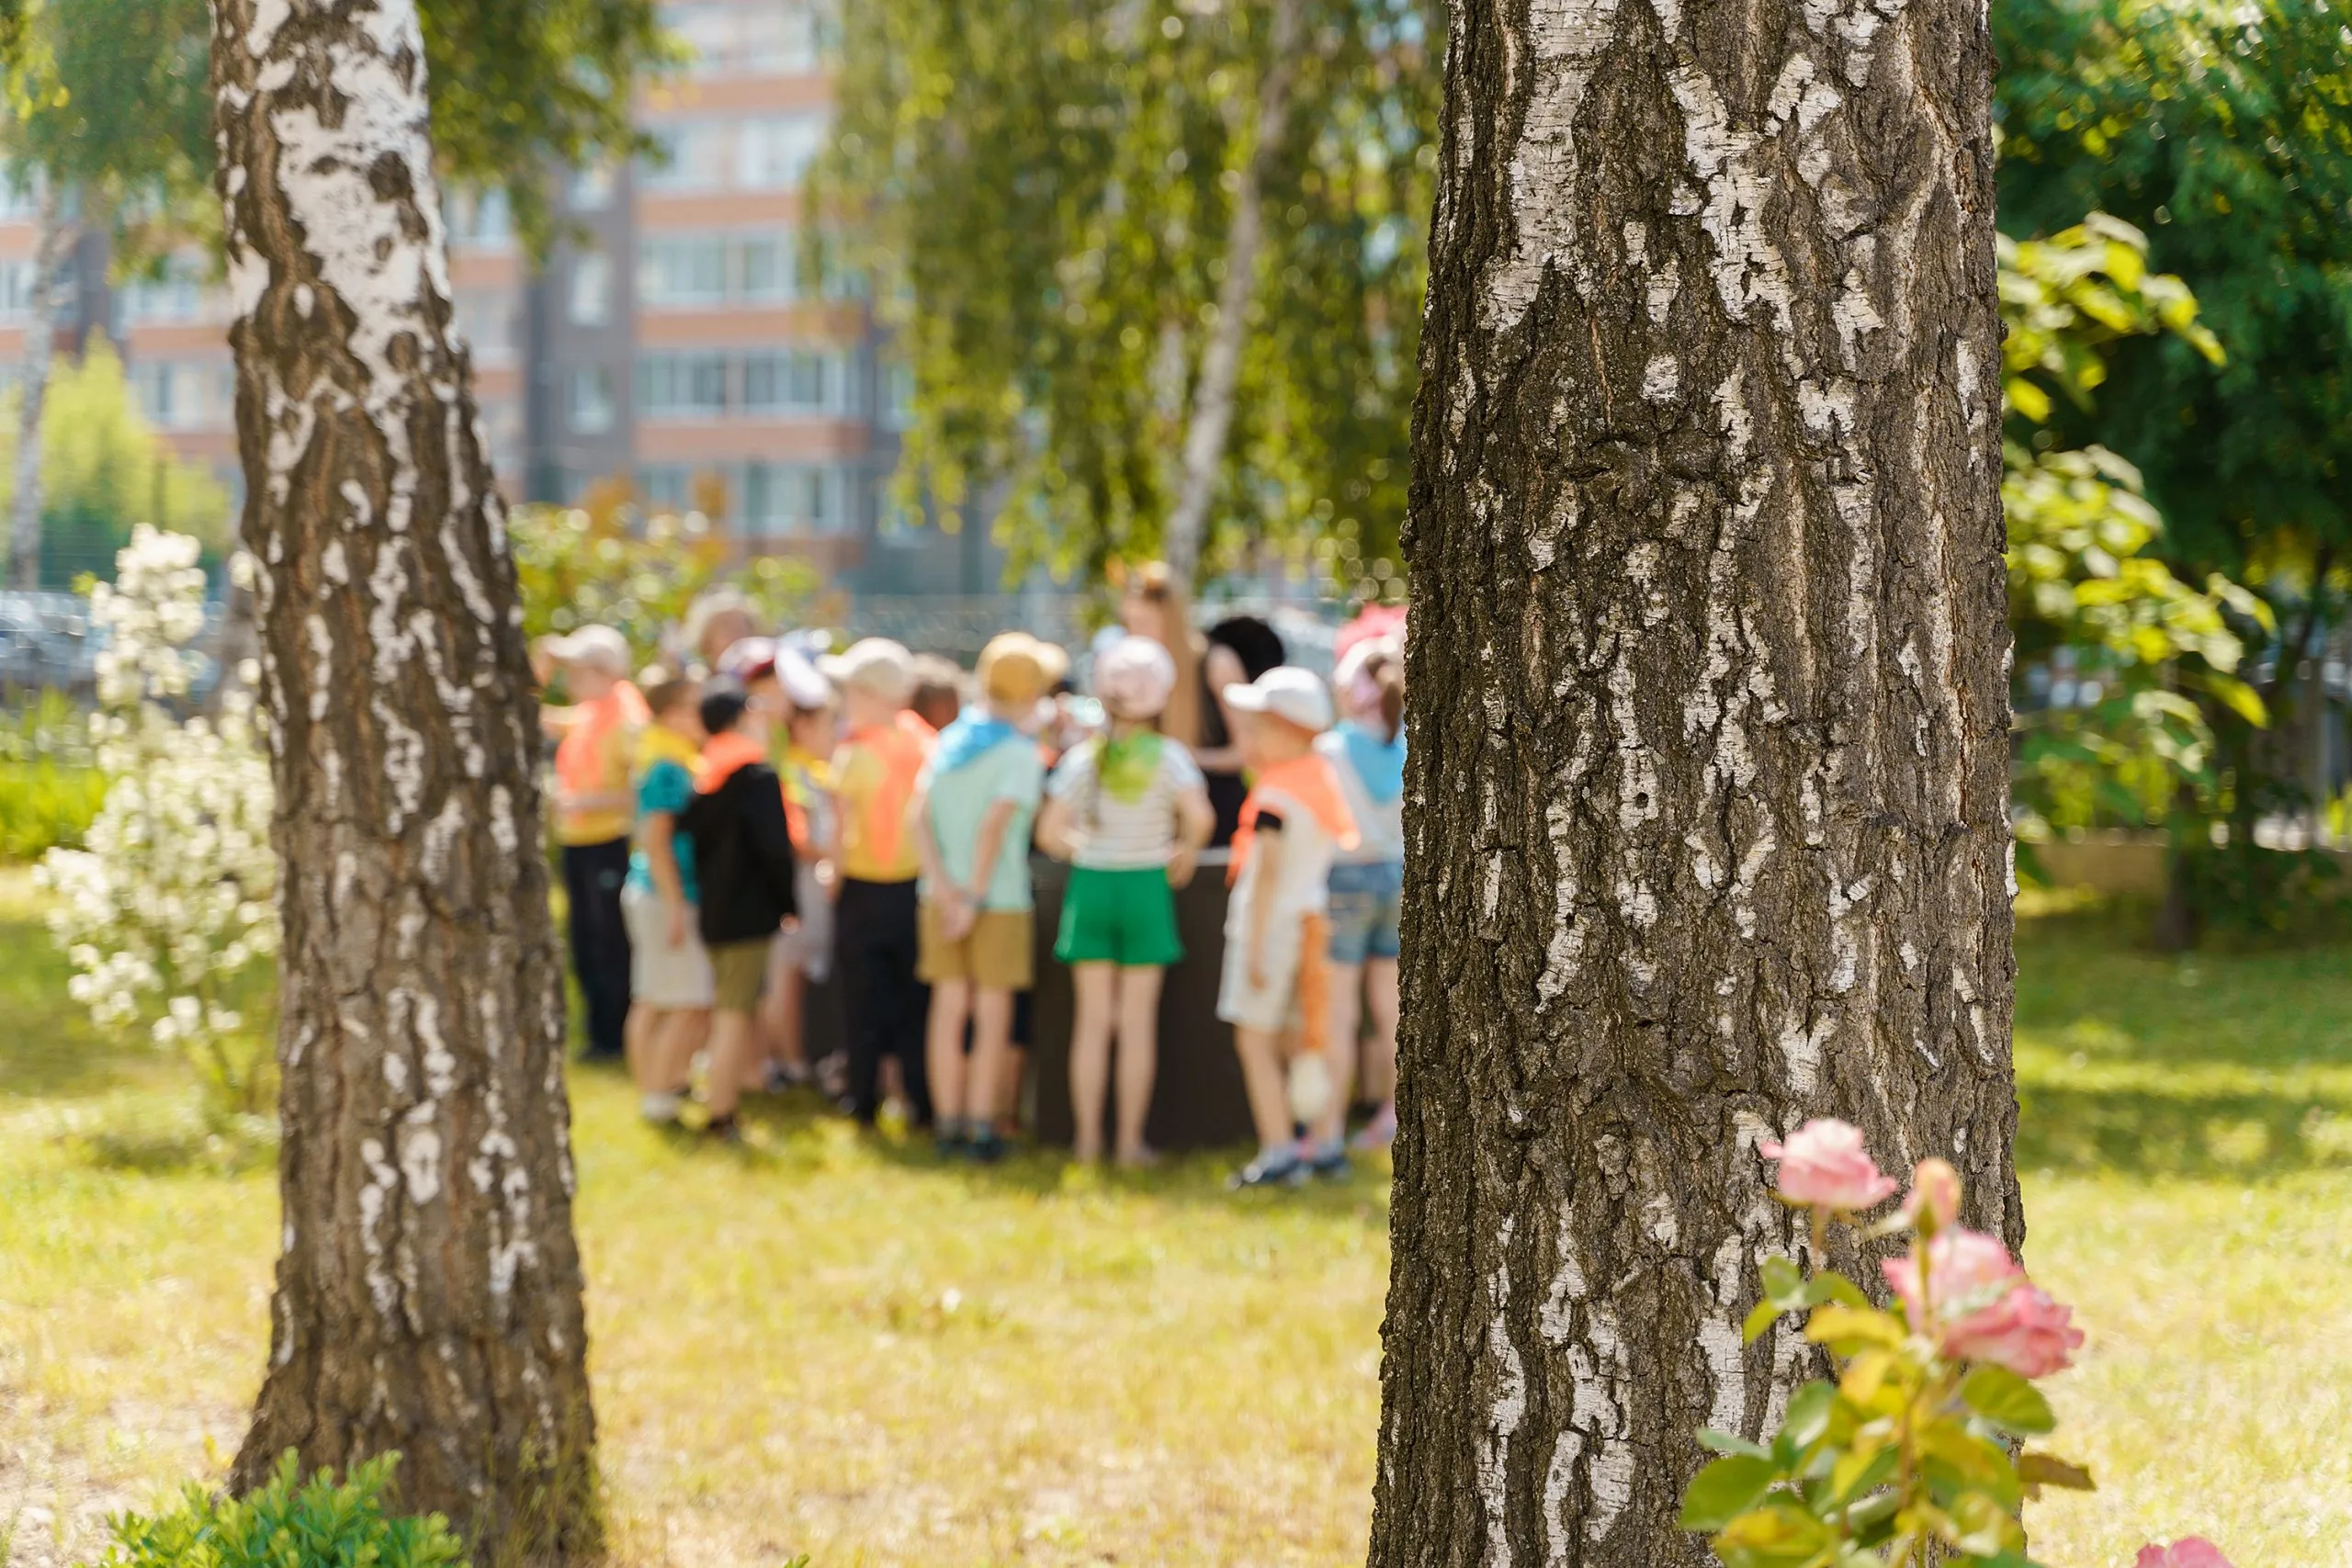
621;672;713;1122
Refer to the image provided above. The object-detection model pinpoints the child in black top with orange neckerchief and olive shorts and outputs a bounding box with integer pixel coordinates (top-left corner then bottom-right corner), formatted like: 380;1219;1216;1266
684;680;793;1140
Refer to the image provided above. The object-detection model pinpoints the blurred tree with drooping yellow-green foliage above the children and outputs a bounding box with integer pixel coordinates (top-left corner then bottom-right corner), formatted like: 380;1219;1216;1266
819;0;1442;594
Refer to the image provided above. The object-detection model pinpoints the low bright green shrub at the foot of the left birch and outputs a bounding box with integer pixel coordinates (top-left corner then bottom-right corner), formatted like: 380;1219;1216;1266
96;1450;466;1568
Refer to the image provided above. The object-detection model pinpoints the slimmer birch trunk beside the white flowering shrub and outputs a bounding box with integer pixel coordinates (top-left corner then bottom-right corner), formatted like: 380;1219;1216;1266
211;0;595;1561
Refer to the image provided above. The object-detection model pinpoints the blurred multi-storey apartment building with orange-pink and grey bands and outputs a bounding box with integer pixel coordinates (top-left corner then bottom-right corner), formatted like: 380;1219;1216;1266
96;0;1002;597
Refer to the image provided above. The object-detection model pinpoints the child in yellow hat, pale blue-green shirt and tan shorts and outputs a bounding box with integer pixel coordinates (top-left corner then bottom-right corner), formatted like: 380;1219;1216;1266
915;632;1066;1161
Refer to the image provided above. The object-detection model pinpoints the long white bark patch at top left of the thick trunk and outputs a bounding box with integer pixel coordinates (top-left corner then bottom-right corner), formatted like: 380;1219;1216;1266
1456;0;1618;331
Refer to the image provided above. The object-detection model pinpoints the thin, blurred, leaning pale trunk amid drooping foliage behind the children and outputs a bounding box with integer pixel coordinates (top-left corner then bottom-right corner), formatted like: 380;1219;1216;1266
1159;0;1306;592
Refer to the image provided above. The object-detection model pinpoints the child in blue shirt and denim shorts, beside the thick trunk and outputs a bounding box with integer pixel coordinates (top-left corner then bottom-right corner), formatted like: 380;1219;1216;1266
1315;637;1404;1166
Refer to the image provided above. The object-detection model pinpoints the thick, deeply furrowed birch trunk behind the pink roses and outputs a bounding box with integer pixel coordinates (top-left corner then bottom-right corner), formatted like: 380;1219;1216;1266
1371;0;2023;1568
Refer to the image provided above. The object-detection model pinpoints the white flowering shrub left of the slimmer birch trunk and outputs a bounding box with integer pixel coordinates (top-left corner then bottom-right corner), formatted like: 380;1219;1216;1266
38;525;277;1114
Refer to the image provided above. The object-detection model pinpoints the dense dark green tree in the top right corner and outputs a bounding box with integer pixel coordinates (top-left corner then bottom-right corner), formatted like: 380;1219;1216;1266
1992;0;2352;698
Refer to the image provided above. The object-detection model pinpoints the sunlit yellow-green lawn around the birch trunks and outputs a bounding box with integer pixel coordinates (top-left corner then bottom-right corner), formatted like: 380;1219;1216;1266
0;882;2352;1568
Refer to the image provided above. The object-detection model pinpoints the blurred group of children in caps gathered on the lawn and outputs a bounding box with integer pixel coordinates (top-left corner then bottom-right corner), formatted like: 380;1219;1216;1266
541;585;1404;1187
